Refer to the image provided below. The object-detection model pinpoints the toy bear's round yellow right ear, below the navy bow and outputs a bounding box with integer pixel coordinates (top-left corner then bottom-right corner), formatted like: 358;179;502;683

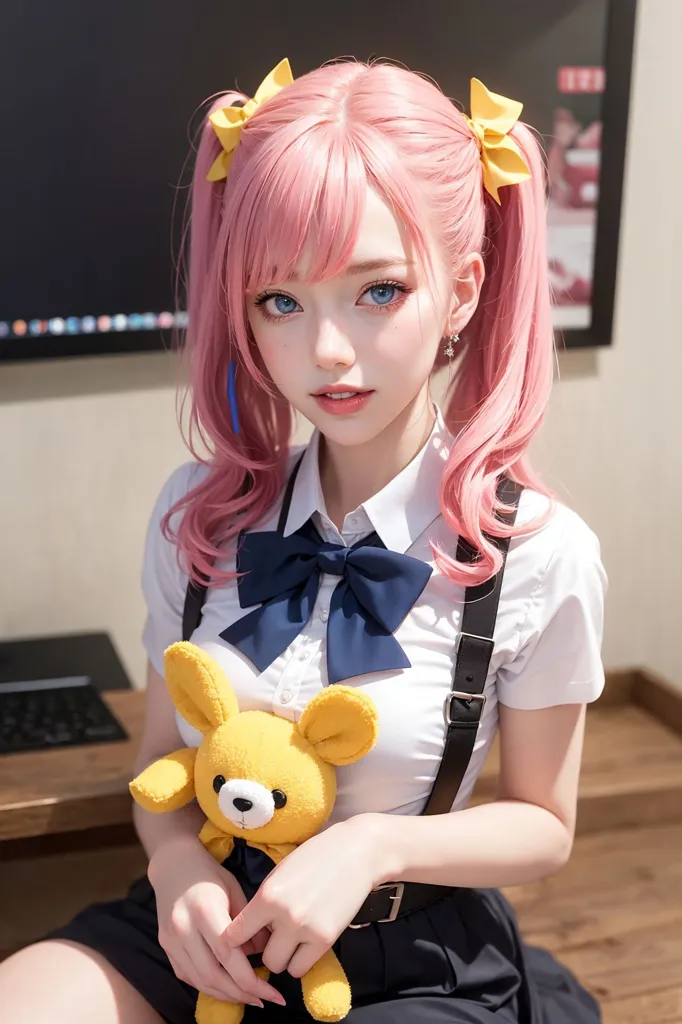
298;684;379;765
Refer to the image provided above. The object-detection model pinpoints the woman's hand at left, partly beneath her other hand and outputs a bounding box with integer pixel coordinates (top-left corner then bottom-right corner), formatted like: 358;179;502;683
148;837;285;1007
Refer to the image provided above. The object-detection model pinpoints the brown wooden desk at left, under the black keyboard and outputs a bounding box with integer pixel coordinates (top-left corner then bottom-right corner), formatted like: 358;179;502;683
0;690;145;841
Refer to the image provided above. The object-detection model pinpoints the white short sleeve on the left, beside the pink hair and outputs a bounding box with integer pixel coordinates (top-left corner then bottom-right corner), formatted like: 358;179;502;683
142;462;205;676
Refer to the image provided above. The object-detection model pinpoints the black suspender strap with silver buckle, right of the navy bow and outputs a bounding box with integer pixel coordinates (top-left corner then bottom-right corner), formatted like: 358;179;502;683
422;477;522;814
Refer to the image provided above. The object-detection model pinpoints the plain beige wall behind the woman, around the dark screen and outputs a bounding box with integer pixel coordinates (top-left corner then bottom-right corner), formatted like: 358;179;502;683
0;0;682;685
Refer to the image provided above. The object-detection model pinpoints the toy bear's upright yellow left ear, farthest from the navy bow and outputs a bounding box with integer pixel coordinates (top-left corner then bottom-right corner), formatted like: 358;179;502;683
164;641;240;734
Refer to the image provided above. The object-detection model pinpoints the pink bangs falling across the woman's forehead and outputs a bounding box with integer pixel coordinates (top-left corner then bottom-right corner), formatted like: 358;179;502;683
225;118;431;293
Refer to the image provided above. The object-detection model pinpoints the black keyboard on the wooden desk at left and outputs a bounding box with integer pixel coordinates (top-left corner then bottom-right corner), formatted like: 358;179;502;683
0;676;128;754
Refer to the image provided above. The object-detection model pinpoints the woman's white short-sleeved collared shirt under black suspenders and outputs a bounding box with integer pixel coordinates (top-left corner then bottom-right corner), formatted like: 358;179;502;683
142;414;606;823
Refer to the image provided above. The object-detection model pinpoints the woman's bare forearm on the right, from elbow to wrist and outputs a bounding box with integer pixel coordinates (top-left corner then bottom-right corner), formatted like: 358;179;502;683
353;800;572;889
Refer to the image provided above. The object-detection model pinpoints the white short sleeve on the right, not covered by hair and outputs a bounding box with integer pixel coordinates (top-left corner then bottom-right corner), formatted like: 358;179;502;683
497;509;607;711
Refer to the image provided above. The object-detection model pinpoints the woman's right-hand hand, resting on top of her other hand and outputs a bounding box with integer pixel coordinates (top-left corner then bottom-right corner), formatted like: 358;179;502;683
223;815;383;978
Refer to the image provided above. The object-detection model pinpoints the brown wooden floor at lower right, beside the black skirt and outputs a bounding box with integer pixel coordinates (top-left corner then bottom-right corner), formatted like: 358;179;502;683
506;822;682;1024
